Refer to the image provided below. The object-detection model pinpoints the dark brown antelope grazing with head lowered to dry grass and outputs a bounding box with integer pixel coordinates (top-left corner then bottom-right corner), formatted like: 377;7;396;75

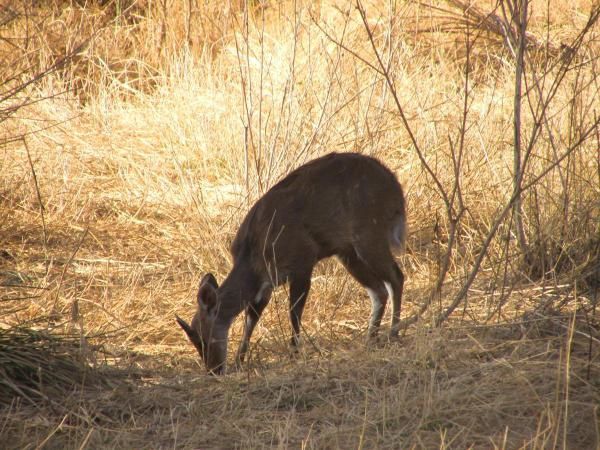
177;153;406;374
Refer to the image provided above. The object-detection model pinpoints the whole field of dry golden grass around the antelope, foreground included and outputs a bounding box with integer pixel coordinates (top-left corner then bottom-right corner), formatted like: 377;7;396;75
0;1;600;448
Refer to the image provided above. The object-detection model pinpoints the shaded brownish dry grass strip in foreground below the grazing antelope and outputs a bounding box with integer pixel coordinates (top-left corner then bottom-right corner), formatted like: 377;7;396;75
2;316;600;448
